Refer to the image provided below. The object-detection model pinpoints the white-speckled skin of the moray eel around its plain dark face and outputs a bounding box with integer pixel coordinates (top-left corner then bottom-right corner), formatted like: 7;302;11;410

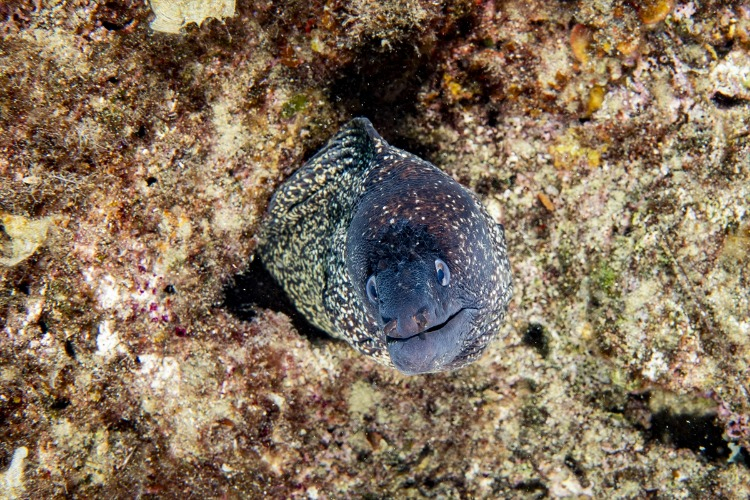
258;118;513;371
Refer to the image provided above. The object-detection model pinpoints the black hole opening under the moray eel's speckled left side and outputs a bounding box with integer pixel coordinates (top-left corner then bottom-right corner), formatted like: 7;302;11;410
223;258;331;340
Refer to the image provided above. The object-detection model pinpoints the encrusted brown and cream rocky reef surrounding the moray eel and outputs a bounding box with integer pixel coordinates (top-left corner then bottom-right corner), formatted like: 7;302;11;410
0;0;750;498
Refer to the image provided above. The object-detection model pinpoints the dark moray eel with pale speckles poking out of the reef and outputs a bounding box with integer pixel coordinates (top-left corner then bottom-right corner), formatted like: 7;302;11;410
257;118;513;374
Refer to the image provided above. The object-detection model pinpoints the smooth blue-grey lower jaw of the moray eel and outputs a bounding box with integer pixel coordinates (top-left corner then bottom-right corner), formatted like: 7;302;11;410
386;307;479;375
